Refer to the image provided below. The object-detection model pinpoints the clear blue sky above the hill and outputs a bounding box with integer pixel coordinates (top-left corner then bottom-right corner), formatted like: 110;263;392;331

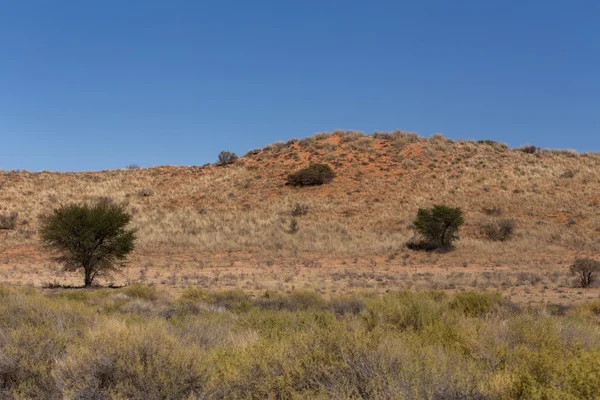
0;0;600;171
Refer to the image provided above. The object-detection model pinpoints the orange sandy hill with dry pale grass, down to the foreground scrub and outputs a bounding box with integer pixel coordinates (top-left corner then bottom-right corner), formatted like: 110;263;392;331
0;131;600;303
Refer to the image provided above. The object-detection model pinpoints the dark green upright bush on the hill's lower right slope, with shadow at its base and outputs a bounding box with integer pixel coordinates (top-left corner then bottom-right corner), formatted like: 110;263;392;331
408;205;464;250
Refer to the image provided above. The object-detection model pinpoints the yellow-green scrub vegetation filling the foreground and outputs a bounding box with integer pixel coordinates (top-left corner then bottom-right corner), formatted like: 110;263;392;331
0;286;600;399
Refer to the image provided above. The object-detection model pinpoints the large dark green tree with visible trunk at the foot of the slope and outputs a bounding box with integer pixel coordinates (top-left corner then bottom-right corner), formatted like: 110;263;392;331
39;202;136;287
